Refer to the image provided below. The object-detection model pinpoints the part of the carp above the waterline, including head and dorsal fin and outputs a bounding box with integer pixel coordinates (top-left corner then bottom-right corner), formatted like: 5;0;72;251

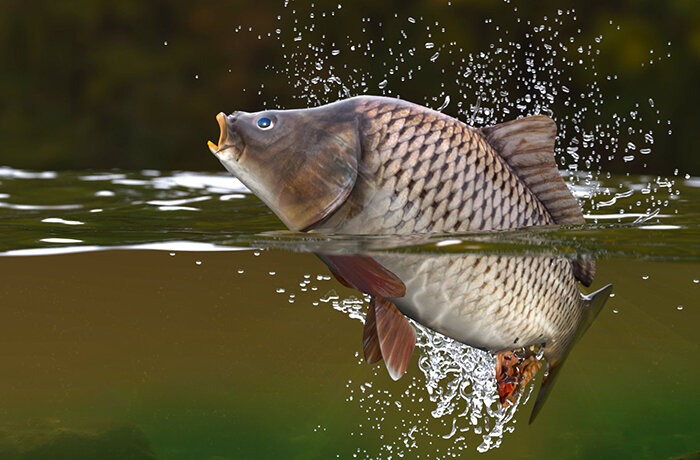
210;96;583;234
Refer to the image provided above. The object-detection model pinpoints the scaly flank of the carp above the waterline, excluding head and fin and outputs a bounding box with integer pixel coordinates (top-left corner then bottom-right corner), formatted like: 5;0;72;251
316;98;554;234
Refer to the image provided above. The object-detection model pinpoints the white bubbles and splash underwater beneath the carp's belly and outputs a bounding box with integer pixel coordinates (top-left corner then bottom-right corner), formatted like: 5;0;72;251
321;291;533;458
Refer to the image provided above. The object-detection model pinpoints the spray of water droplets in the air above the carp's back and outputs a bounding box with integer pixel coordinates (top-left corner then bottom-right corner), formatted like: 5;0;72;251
232;0;674;221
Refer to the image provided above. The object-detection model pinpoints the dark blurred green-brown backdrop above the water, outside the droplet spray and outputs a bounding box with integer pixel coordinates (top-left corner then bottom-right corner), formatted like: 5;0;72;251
0;0;700;174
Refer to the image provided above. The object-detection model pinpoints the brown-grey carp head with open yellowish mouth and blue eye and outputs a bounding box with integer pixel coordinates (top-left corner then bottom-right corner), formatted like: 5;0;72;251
208;103;361;231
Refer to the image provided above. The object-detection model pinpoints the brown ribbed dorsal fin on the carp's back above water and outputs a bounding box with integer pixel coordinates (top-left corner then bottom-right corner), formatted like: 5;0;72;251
481;115;584;225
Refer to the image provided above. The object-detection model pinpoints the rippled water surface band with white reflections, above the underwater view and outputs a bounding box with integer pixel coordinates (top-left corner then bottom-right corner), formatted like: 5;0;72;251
0;168;700;260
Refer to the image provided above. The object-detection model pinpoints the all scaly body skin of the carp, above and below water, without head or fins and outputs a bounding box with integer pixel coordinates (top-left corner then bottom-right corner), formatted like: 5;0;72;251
306;97;583;359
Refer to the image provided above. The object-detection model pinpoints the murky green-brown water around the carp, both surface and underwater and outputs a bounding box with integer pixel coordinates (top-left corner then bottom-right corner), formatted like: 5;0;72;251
0;168;700;459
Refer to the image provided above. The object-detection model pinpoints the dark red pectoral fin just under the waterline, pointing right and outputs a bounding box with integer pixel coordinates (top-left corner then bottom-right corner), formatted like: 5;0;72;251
317;254;406;297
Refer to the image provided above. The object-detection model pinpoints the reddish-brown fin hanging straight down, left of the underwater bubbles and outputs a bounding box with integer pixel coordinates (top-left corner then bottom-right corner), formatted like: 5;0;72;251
374;297;416;380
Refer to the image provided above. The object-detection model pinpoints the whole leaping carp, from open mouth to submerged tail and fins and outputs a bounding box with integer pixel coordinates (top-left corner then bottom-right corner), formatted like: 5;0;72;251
208;96;612;420
